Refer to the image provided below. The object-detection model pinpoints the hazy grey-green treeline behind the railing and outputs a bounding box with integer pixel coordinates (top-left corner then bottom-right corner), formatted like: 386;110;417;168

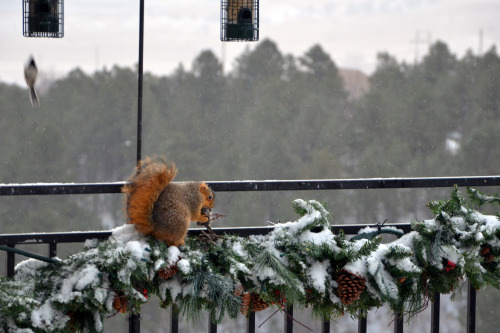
0;40;500;233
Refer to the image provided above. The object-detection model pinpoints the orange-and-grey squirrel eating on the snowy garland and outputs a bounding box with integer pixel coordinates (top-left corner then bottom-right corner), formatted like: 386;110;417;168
122;158;215;246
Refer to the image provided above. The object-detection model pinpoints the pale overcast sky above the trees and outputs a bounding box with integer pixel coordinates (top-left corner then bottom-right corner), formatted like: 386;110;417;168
0;0;500;84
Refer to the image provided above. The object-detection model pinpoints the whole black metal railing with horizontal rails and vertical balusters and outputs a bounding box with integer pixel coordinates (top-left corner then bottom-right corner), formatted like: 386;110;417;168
0;176;500;333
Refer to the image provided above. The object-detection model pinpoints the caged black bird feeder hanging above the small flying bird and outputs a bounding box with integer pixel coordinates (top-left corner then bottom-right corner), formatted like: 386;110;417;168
23;0;64;38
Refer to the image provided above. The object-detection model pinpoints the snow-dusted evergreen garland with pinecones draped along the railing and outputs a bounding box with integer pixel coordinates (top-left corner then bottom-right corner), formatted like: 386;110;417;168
0;188;500;332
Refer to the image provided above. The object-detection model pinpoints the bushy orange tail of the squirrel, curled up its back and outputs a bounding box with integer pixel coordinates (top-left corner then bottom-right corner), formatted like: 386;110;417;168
122;158;177;235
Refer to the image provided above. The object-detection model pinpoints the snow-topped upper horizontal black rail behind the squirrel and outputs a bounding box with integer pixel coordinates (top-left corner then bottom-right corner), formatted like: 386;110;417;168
0;176;500;196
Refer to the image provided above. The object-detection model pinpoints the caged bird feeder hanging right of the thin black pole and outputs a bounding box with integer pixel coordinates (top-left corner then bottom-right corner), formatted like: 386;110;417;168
220;0;259;42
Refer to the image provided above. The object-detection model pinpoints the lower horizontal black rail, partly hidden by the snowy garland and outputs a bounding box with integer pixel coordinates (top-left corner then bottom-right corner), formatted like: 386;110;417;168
0;223;411;245
